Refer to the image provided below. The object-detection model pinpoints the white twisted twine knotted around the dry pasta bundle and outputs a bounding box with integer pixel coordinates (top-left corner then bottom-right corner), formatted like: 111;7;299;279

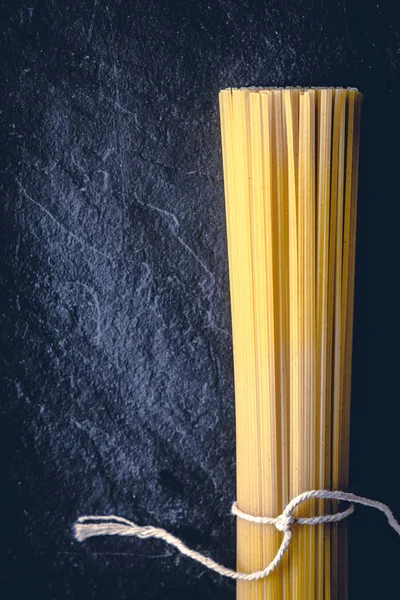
74;490;400;581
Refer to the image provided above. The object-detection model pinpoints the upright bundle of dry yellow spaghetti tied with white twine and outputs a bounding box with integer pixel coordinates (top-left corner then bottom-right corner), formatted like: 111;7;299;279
220;88;362;600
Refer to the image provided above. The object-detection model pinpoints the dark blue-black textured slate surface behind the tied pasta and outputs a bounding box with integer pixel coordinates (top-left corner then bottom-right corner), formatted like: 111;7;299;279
0;0;400;600
